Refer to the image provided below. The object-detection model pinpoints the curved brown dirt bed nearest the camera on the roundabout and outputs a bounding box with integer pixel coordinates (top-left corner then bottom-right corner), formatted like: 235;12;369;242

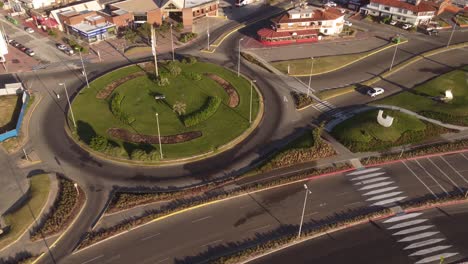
107;128;202;144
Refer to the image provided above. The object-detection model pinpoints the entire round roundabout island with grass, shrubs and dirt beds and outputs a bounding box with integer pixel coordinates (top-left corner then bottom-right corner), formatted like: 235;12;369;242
69;58;263;163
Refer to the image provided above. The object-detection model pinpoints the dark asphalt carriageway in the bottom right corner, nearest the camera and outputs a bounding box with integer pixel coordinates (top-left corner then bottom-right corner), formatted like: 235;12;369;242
249;205;468;264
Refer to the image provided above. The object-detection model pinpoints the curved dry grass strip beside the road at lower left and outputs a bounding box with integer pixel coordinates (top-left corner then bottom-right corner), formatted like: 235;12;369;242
0;174;50;249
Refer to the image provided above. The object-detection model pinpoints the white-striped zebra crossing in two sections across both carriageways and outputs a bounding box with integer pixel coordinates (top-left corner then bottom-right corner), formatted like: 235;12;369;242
346;168;460;264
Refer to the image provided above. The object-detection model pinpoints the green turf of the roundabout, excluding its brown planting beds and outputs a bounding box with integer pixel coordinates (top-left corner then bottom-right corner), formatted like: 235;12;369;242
73;62;259;158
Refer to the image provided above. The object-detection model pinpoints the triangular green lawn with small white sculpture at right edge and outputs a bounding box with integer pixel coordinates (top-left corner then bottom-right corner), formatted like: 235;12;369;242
375;66;468;126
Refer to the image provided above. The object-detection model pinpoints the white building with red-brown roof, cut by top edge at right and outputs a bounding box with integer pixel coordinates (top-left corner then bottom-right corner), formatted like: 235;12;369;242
361;0;437;25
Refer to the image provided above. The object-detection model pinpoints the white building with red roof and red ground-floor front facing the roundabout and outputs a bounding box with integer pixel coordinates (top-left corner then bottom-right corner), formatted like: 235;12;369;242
257;5;344;45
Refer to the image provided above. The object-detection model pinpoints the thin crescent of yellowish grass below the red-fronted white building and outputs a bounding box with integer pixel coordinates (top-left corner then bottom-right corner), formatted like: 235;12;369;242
271;42;394;75
